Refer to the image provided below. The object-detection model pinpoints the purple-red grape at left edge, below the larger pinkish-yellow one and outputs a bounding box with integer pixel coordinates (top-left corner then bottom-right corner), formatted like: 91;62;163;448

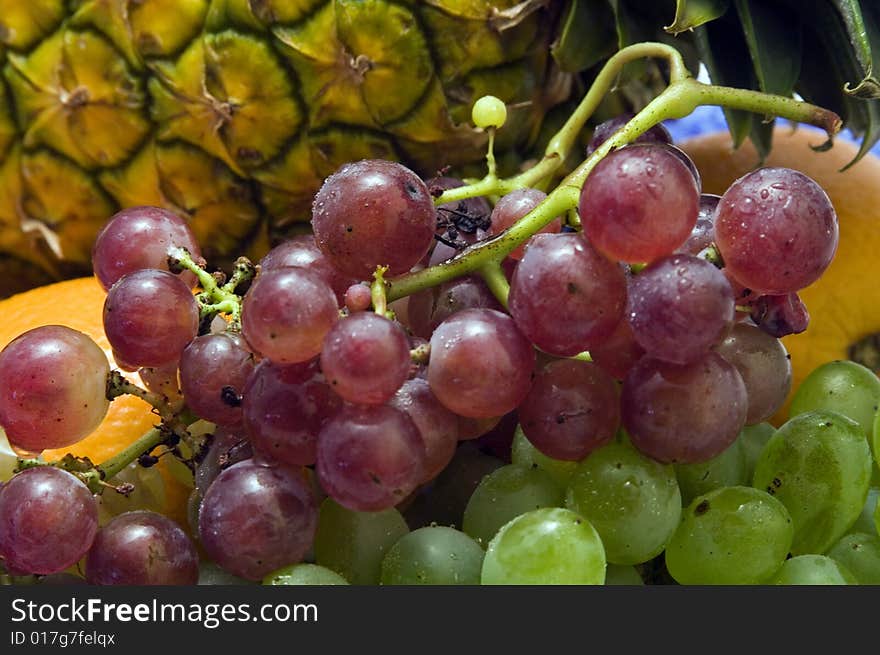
0;466;98;574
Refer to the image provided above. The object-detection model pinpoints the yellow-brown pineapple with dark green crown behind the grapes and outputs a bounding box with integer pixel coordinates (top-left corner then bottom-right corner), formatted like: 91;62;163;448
0;0;880;297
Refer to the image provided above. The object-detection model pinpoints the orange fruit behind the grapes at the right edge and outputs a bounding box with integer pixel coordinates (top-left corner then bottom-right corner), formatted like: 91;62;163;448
682;128;880;424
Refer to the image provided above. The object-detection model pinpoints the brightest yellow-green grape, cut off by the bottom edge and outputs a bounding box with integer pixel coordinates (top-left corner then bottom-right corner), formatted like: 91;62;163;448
480;507;606;585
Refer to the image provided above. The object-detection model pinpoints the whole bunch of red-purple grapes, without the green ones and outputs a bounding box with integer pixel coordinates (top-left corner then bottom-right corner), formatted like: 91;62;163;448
0;115;838;584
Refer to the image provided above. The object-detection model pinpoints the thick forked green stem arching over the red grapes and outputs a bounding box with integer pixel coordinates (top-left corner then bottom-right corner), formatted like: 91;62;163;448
385;42;842;302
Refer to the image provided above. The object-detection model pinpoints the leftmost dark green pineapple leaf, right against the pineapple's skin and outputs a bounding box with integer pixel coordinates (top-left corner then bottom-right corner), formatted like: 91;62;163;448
550;0;617;73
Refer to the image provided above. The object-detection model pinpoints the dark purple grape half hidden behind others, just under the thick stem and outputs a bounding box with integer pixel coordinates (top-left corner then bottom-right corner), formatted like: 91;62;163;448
407;275;503;339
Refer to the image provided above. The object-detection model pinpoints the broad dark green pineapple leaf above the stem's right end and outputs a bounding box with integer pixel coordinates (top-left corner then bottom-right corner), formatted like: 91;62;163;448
734;0;802;96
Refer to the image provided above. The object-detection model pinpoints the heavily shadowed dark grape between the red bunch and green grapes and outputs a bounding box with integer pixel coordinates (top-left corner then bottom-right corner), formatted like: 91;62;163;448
403;441;504;530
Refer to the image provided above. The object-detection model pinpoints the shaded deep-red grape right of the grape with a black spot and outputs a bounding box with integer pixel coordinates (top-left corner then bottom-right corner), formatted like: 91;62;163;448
242;360;342;466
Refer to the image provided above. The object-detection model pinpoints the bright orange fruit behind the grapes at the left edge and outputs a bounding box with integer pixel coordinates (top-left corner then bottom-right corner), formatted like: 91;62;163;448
0;277;189;526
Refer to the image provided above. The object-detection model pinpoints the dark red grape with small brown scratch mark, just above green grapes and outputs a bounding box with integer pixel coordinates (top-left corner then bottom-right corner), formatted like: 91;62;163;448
518;359;620;461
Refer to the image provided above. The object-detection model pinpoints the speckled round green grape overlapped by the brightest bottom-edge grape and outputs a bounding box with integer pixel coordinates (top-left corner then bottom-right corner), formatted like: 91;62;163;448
565;441;681;564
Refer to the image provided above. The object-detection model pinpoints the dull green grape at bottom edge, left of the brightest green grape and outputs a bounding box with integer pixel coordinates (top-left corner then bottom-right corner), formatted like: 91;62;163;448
382;526;485;585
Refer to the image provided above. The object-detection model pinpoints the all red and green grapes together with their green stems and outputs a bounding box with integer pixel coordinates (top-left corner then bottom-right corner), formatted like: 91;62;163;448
0;36;880;585
